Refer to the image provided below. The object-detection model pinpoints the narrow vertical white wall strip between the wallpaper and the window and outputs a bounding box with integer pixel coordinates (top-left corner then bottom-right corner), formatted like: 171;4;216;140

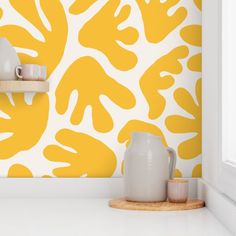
202;0;221;187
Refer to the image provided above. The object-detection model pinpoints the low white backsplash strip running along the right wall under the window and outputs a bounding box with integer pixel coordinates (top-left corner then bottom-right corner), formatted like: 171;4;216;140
198;179;236;235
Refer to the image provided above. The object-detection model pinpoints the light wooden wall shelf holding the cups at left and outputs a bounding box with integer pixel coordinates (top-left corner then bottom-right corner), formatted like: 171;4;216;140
0;80;49;93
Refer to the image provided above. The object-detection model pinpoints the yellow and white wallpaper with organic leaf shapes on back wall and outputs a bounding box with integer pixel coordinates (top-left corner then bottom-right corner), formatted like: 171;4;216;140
0;0;201;177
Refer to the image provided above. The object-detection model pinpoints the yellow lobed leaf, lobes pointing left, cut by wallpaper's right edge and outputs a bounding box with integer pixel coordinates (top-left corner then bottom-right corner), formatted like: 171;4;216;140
166;79;202;159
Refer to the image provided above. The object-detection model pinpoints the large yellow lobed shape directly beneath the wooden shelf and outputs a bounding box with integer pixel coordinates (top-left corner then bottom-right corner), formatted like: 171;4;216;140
0;93;49;159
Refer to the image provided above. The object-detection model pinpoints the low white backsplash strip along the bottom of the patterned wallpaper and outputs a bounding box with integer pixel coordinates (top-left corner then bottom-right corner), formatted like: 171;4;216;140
0;178;197;198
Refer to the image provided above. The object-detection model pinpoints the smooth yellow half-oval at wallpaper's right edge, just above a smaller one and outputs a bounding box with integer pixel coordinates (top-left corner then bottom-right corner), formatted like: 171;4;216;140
180;25;202;47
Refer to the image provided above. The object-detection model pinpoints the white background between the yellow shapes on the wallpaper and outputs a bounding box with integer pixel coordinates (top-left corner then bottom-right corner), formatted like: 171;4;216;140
0;0;201;177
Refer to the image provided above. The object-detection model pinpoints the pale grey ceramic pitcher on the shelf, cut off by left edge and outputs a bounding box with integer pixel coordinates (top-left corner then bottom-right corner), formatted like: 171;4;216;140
0;38;20;80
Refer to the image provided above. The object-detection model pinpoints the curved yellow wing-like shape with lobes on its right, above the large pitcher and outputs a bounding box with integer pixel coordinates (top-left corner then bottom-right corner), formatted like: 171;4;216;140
140;46;188;119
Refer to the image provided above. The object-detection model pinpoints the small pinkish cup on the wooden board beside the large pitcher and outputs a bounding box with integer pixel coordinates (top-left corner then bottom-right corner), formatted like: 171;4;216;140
167;179;188;203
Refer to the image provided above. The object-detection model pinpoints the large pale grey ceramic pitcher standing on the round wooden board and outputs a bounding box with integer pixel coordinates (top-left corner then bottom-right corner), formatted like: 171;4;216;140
124;132;176;202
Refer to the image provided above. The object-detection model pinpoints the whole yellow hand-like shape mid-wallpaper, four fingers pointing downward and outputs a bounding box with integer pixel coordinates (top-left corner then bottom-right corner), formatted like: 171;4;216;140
56;57;135;132
